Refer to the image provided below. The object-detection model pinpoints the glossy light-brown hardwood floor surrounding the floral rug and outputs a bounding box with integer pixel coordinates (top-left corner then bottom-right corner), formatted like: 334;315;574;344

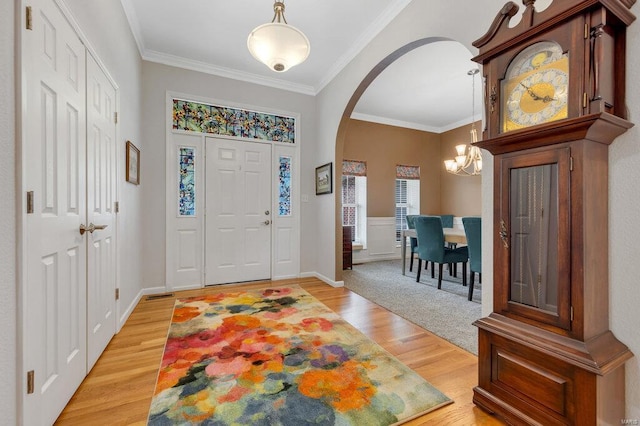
56;278;503;426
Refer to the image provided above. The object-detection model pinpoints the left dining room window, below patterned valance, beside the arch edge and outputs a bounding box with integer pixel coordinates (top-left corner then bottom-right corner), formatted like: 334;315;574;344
342;175;367;246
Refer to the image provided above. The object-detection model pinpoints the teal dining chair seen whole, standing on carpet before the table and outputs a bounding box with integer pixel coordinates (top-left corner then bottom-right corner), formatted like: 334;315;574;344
414;216;469;289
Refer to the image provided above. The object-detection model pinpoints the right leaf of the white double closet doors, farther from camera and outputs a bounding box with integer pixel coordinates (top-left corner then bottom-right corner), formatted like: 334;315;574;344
85;55;116;370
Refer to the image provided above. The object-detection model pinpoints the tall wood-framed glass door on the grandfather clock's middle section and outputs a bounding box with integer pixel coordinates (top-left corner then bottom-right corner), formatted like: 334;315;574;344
497;148;571;329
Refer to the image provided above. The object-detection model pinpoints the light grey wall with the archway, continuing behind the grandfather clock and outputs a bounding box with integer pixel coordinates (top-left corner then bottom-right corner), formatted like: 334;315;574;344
317;0;640;419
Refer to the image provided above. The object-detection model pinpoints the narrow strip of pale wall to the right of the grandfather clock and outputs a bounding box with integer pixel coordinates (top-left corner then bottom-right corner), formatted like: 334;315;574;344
608;3;640;419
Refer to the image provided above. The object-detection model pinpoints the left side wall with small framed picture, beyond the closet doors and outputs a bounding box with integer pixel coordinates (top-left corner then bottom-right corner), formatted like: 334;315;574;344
64;0;146;321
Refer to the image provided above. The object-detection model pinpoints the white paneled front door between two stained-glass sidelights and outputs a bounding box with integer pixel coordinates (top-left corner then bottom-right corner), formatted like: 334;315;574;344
205;138;272;285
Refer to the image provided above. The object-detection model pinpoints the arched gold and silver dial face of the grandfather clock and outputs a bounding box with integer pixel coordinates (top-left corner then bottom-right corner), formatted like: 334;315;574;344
502;42;569;132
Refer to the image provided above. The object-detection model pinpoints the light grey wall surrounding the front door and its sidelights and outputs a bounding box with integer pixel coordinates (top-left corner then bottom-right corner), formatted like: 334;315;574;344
141;61;319;288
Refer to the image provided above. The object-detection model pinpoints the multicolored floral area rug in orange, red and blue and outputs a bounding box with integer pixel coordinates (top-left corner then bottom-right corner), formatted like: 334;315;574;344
148;286;452;426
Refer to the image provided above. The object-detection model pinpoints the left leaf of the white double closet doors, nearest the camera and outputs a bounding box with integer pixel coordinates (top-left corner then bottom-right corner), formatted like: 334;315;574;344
22;0;87;425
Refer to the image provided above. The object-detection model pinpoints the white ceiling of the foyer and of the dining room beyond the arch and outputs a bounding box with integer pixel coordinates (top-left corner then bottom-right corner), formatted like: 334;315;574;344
121;0;481;132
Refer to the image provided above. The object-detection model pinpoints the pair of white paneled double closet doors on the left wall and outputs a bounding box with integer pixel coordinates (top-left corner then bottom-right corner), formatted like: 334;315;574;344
19;0;116;425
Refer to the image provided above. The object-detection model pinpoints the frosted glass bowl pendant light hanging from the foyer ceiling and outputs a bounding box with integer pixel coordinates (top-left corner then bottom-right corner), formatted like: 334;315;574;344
247;1;311;72
